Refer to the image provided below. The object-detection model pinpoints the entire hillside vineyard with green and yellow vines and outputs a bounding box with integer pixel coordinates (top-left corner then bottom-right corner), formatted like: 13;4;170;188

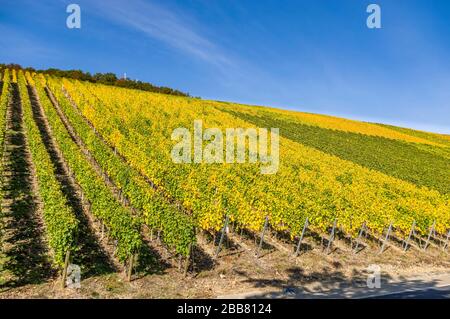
0;69;450;298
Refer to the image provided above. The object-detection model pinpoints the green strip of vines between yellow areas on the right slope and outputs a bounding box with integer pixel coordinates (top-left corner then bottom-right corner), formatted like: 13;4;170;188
223;109;450;194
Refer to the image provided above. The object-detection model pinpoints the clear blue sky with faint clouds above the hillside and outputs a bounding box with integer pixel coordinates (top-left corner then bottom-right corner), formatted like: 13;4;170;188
0;0;450;133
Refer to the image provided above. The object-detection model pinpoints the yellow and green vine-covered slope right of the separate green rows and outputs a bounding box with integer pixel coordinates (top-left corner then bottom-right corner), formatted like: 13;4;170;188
50;75;450;240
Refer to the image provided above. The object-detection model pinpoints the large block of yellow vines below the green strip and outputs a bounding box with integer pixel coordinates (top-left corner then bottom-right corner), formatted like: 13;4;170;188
59;80;450;241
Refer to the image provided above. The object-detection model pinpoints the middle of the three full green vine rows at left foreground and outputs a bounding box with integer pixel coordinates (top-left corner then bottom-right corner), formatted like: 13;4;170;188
26;73;143;261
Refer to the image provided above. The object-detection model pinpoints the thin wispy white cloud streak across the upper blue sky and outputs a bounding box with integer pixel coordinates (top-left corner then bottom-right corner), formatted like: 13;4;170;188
89;0;235;70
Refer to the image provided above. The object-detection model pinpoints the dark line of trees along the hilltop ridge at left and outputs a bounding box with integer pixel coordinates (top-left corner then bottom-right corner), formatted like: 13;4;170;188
0;64;189;96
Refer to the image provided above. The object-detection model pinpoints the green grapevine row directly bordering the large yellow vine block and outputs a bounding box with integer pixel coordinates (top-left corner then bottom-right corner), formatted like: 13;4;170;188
44;77;196;255
